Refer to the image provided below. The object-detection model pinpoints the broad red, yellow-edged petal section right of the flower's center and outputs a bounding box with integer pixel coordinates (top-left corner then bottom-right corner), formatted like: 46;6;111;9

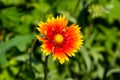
63;25;82;56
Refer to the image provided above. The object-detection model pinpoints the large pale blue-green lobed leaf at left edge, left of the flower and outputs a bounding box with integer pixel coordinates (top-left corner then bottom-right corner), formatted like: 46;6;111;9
0;34;33;67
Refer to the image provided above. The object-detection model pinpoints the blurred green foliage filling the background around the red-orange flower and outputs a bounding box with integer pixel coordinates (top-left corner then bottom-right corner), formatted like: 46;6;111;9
0;0;120;80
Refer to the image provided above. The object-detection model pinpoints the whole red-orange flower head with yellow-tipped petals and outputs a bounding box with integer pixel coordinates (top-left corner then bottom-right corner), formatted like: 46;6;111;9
37;16;83;64
